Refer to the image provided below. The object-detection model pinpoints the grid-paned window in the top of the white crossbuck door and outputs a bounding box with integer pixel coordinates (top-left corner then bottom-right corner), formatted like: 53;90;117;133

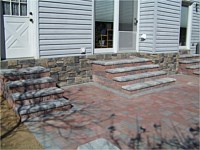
2;0;27;16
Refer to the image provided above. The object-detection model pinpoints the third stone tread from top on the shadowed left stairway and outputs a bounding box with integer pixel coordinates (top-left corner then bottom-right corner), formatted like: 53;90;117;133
12;87;64;101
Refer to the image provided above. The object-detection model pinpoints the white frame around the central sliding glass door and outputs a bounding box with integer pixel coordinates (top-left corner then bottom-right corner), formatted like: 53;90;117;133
92;0;140;54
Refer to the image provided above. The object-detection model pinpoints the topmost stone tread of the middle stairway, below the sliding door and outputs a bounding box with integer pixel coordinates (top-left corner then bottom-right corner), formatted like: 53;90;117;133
93;58;150;66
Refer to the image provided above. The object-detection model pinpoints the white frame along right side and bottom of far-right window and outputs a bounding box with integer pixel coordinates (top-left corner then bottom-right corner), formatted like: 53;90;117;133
179;4;193;50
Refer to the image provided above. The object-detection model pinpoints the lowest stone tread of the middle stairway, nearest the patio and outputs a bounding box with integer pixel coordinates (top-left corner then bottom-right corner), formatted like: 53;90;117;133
122;78;176;91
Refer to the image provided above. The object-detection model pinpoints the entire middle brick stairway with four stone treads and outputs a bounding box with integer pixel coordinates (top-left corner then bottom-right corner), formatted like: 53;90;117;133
92;57;176;94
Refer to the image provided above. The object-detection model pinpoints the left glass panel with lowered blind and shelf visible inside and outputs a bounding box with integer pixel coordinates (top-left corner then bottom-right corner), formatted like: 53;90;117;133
94;0;114;49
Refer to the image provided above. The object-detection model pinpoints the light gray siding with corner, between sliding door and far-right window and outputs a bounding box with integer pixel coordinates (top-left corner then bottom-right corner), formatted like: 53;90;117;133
139;0;181;53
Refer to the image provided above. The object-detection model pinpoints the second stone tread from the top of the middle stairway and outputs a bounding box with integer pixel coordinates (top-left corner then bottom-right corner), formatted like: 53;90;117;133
106;65;159;74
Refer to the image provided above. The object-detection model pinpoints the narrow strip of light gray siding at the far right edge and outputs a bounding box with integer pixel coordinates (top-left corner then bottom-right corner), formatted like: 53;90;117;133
190;0;200;53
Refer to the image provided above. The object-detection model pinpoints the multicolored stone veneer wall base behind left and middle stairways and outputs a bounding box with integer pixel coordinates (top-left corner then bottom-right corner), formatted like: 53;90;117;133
1;53;179;87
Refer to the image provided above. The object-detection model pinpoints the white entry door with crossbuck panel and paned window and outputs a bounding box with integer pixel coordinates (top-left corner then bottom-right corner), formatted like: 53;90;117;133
3;0;33;58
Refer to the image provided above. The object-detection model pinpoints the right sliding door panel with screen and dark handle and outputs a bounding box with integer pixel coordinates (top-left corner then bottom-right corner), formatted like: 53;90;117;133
119;0;137;51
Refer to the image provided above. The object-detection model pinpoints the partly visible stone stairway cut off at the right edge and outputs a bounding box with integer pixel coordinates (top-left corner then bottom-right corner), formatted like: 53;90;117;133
179;54;200;76
